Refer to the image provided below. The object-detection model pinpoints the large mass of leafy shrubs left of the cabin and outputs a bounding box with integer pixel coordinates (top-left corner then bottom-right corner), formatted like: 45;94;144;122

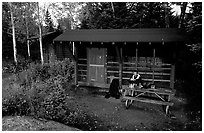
2;59;73;119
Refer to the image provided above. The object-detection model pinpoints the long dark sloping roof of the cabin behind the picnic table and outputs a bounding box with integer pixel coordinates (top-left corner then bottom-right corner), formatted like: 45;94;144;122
54;28;186;42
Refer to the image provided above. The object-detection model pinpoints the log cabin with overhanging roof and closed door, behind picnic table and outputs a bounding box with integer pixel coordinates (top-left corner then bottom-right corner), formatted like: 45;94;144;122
54;28;186;89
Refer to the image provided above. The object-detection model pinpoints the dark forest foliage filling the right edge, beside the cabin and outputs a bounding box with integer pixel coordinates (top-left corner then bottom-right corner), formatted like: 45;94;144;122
173;2;202;130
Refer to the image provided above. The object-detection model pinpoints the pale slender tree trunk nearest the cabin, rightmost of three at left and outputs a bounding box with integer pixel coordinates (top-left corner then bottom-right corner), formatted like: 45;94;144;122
38;2;44;65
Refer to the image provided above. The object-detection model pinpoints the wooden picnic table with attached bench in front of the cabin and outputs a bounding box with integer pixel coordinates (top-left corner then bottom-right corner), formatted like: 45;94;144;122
123;86;175;114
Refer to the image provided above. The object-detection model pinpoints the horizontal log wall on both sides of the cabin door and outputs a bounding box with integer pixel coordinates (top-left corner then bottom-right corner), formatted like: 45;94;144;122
78;44;174;88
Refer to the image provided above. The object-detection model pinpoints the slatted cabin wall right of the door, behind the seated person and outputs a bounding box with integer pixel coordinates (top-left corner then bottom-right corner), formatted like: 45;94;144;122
107;43;172;87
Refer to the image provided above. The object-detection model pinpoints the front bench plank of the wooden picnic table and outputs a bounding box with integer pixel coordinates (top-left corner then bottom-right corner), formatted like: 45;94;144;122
123;96;174;106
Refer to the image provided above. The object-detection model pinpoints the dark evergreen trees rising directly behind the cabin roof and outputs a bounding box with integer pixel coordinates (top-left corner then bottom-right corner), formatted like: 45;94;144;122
80;2;176;29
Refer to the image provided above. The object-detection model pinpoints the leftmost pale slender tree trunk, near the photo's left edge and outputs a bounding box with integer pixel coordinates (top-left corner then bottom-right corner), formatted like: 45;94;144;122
9;2;17;65
